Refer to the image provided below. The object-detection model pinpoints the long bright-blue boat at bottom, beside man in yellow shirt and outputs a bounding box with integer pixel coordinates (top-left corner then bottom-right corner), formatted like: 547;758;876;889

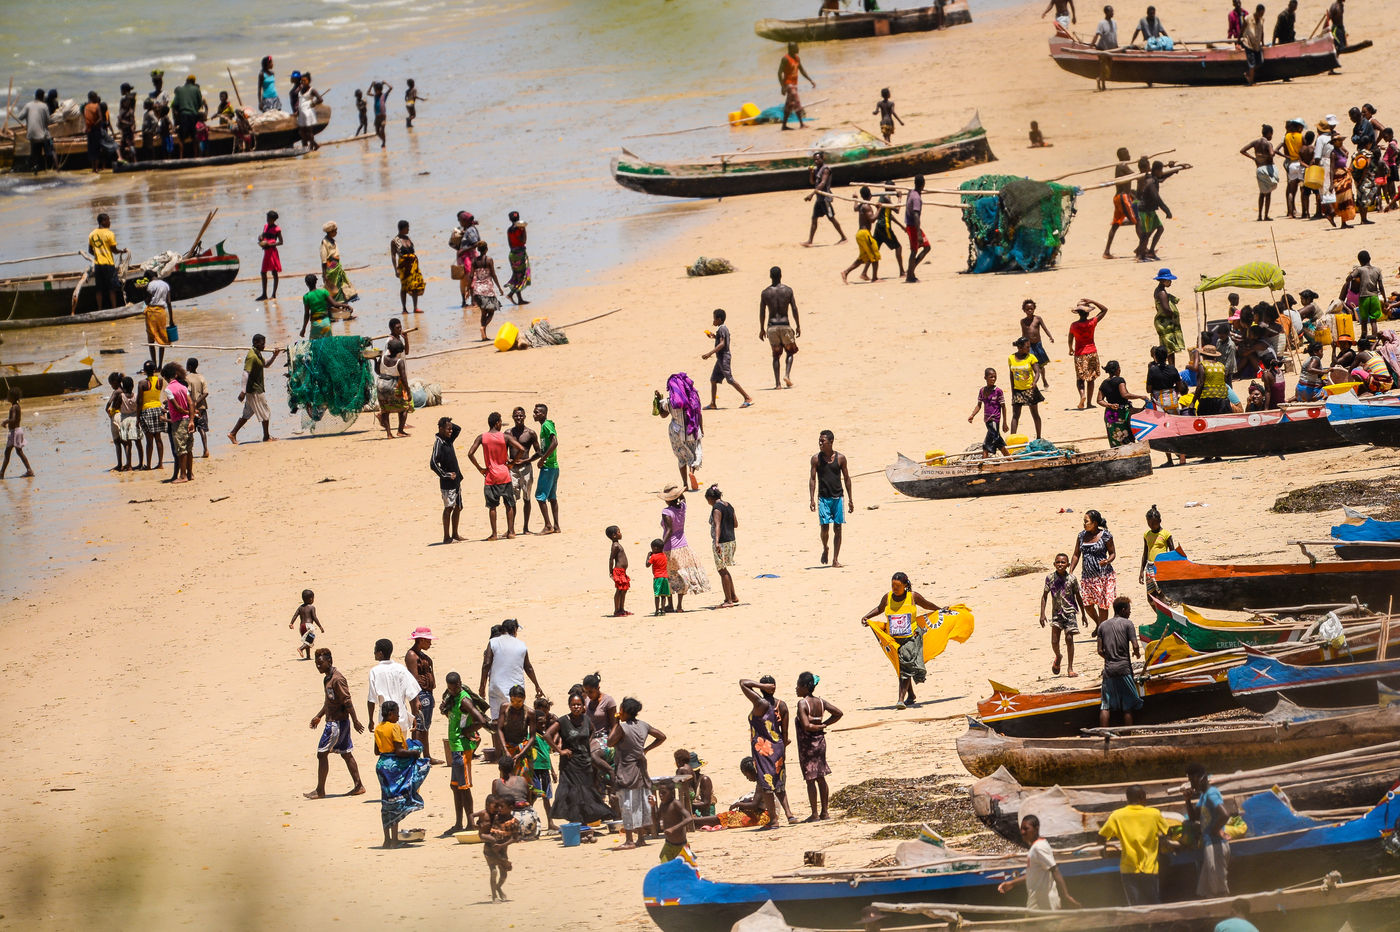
641;791;1400;932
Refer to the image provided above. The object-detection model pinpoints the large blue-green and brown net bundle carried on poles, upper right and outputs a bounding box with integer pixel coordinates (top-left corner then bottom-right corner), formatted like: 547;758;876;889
958;175;1078;273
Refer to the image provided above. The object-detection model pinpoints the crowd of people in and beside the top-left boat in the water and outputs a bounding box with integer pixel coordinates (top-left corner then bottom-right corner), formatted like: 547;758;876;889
17;56;428;174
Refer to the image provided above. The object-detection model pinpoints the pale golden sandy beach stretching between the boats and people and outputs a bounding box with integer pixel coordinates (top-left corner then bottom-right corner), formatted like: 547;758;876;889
0;3;1400;929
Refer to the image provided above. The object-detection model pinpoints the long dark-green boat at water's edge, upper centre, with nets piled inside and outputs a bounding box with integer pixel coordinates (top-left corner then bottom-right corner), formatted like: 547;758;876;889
612;116;997;197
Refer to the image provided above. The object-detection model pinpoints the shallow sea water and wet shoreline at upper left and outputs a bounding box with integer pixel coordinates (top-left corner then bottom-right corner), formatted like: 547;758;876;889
0;0;1007;592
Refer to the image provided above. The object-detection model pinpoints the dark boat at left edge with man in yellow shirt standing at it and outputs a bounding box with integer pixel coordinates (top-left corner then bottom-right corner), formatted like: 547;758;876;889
0;242;238;329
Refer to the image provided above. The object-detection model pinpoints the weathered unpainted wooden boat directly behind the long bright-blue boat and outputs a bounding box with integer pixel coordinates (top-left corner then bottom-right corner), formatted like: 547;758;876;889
967;740;1400;848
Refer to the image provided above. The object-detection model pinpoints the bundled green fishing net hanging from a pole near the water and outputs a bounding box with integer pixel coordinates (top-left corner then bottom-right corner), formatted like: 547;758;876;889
287;336;375;431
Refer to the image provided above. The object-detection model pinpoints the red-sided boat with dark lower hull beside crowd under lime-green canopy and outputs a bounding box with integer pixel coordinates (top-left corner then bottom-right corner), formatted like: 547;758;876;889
1133;404;1351;456
